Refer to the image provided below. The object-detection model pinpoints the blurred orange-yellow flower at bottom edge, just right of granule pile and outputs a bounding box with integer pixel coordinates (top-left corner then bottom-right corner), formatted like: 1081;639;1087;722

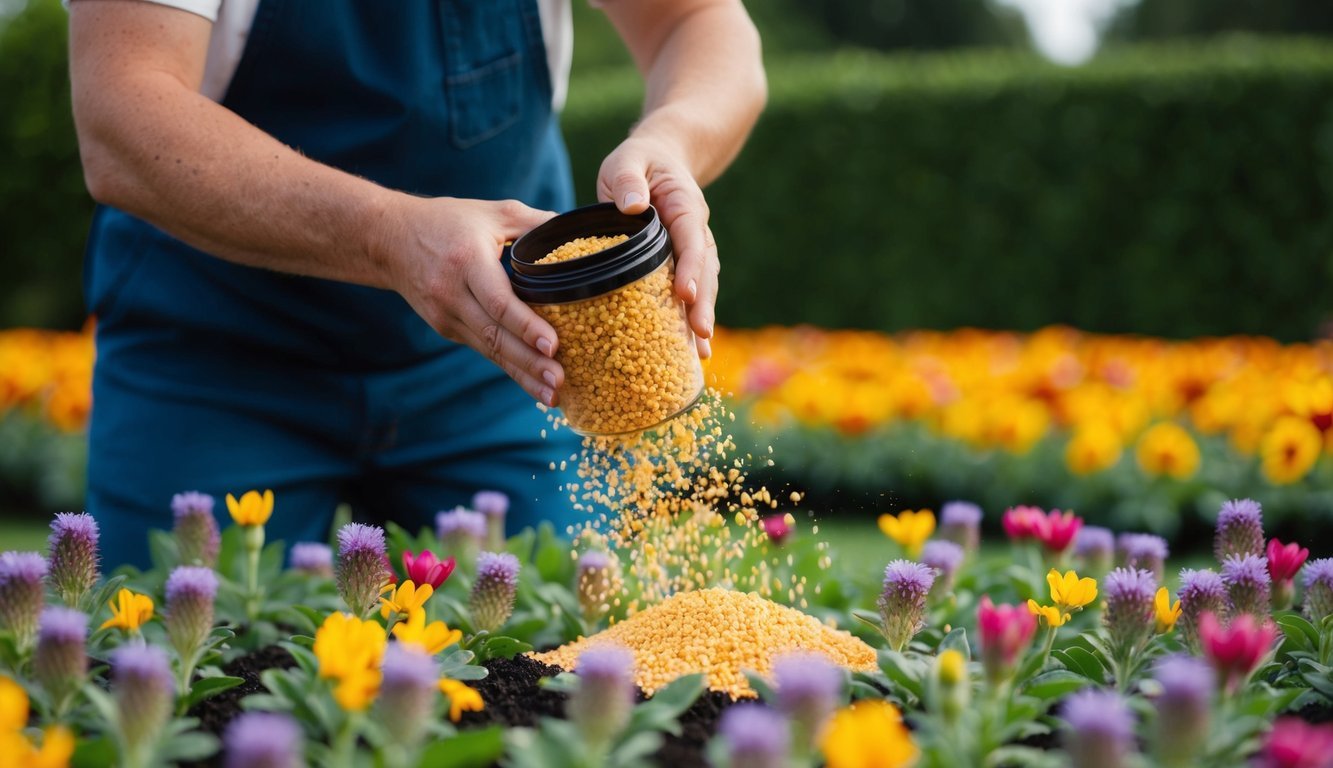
820;699;918;768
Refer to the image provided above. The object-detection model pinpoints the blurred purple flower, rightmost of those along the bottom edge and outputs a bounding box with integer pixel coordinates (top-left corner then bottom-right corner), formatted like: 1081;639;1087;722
1154;655;1217;765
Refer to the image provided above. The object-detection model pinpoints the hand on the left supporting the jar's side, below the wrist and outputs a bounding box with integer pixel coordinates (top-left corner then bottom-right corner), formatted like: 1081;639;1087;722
381;196;565;405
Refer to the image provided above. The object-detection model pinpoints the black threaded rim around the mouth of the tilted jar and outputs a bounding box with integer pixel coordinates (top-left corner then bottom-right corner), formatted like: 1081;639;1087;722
509;203;672;304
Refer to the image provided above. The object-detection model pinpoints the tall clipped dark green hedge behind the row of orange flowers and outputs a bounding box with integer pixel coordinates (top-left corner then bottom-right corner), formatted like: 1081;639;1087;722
565;39;1333;339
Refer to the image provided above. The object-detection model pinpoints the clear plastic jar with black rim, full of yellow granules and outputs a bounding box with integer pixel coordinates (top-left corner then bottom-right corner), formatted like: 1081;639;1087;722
509;203;704;435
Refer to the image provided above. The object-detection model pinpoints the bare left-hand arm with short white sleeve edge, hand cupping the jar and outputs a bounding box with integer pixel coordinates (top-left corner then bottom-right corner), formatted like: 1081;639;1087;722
69;0;564;404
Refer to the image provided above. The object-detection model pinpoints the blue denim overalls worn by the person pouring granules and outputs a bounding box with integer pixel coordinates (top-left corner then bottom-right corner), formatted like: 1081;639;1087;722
84;0;577;565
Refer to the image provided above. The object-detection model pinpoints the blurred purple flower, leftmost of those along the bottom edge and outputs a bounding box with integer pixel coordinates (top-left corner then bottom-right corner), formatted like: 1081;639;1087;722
111;645;175;753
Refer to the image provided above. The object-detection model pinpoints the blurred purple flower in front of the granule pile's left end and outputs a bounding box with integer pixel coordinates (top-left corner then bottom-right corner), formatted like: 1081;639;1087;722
567;645;635;744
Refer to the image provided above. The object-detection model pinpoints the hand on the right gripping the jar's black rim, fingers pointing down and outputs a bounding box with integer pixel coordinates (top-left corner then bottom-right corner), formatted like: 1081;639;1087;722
597;136;721;357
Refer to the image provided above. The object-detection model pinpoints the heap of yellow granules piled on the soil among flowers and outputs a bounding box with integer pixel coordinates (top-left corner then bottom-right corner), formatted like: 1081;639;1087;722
532;588;876;699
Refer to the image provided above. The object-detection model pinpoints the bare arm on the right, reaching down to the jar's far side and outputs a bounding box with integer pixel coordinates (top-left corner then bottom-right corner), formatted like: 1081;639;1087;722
597;0;766;356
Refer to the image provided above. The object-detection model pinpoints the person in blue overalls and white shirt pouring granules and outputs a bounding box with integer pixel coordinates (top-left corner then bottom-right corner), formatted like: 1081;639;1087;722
69;0;766;564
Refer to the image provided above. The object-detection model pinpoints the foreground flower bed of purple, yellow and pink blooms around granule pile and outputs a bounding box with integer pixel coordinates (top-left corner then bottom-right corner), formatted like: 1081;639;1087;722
0;492;1333;768
